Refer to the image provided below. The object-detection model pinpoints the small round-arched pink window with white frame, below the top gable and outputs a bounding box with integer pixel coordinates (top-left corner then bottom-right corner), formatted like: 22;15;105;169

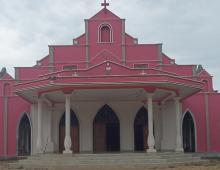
99;24;112;43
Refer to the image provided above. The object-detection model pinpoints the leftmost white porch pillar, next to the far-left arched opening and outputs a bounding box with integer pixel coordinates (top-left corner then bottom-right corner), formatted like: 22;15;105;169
37;98;43;153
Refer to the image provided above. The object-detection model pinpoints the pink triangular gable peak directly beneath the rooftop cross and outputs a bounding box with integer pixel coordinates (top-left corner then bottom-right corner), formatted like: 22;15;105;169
89;8;121;20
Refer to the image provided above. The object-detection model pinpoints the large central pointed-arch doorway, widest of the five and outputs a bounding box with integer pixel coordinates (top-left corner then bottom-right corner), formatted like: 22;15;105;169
93;105;120;152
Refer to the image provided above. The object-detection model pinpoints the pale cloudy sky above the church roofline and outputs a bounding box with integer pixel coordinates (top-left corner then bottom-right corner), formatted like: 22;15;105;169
0;0;220;90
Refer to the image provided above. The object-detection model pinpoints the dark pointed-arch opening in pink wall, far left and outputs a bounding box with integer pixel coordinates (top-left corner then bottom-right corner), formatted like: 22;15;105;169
18;114;31;156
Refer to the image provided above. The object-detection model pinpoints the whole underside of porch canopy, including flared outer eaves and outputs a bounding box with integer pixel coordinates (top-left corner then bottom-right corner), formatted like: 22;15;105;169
15;84;200;103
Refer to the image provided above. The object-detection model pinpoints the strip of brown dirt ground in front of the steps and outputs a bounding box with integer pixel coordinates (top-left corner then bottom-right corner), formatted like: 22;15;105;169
0;160;220;170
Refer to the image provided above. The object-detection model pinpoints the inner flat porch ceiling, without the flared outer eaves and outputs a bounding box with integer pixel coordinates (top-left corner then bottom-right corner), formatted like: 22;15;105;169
42;89;170;103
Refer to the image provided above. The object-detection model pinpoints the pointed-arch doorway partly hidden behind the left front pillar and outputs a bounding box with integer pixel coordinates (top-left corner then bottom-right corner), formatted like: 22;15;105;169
59;110;79;153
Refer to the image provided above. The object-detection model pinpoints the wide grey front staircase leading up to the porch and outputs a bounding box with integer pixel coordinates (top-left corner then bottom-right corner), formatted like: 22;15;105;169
8;152;208;169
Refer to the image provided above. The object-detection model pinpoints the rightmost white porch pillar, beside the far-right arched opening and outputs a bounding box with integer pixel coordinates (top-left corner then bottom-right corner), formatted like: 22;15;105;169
174;97;183;152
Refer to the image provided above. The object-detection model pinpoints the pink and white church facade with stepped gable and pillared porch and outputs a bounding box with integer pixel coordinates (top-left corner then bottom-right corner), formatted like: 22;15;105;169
0;3;220;157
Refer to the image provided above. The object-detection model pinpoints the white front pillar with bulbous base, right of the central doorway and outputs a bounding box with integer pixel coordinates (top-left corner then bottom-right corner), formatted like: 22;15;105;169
147;93;156;152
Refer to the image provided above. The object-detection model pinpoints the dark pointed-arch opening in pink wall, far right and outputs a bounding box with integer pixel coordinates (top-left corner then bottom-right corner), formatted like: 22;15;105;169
182;112;195;152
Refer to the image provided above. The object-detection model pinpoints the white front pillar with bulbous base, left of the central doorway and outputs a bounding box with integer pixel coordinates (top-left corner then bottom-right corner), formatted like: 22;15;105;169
63;94;72;154
